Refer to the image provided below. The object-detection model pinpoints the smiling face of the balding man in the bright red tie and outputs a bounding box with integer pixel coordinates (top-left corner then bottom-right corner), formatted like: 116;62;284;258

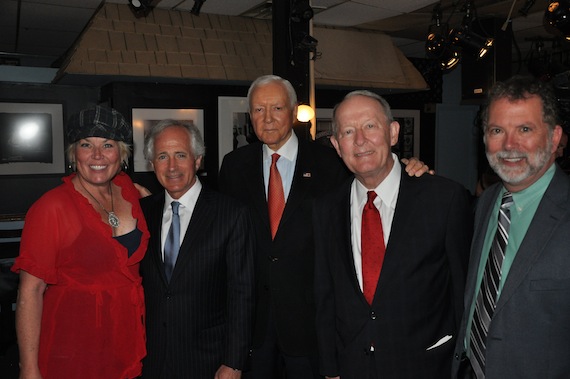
331;95;400;189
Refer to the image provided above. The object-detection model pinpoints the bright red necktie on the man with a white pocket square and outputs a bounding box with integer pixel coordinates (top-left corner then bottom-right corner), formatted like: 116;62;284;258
361;191;386;304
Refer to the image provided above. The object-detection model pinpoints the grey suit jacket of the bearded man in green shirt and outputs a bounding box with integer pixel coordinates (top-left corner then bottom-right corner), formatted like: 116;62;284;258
452;167;570;379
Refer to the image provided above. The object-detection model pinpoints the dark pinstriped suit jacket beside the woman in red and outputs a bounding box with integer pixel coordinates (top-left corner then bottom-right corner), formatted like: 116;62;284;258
141;187;254;379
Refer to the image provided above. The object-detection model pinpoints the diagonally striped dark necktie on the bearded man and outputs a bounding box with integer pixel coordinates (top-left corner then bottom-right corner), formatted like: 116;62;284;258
470;192;513;379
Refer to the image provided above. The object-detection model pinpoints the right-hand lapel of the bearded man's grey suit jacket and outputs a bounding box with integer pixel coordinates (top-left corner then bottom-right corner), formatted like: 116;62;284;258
495;168;570;312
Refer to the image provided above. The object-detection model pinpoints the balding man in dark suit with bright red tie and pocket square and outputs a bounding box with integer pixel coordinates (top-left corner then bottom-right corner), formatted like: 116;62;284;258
313;91;472;379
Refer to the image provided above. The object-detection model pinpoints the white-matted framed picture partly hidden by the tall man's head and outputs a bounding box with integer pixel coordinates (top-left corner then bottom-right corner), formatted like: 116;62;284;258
218;96;257;168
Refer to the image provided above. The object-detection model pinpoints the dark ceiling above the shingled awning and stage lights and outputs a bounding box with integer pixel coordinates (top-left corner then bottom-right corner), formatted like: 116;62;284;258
0;0;570;73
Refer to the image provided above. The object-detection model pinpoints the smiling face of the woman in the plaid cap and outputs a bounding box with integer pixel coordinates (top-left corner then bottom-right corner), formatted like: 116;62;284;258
74;137;121;185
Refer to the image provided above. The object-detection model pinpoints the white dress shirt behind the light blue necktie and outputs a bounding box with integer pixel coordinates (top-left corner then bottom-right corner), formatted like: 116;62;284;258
160;177;202;261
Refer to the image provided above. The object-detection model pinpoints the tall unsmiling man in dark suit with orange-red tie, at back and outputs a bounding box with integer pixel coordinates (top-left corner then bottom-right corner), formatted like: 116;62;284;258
219;75;427;379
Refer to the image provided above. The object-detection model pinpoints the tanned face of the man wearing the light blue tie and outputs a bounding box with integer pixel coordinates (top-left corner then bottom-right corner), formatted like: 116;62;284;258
151;126;202;199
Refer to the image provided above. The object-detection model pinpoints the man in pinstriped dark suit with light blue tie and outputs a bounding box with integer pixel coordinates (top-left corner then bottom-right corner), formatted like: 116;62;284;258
141;120;253;379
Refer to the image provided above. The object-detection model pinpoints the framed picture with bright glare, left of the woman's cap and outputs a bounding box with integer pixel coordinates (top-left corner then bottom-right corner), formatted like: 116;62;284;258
0;103;65;175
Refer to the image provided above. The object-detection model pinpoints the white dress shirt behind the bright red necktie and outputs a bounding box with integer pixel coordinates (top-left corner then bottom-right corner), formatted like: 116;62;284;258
350;154;402;290
